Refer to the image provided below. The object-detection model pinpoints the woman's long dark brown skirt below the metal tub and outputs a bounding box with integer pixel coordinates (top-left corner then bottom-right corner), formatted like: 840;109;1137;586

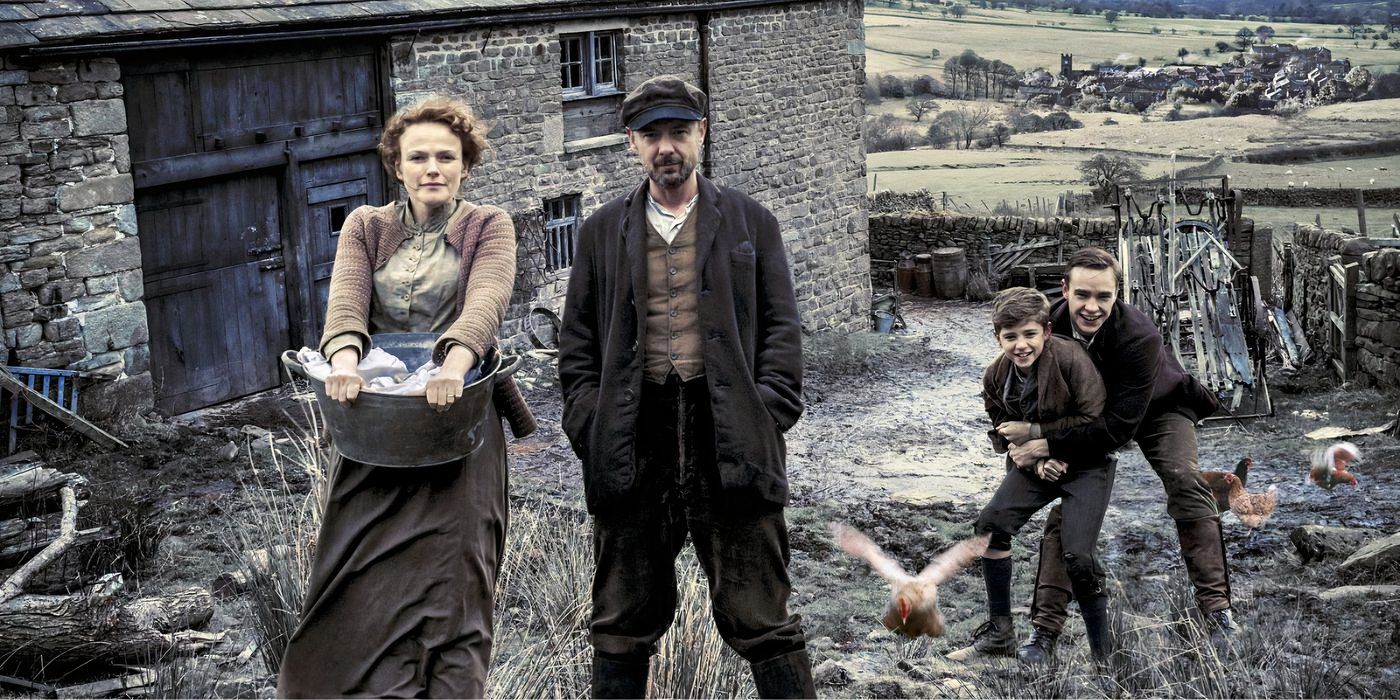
277;407;508;697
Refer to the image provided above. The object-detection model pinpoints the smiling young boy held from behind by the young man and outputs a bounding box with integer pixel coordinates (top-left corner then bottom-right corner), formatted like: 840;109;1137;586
949;287;1116;661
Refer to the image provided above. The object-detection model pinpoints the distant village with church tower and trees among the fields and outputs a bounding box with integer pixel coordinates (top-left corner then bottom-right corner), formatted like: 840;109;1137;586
1018;43;1368;111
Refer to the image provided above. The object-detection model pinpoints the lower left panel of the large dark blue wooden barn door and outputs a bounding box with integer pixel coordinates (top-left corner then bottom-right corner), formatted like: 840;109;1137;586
137;172;288;413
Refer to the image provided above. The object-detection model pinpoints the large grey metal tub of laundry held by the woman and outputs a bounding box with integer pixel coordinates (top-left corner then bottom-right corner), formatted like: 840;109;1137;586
281;333;519;466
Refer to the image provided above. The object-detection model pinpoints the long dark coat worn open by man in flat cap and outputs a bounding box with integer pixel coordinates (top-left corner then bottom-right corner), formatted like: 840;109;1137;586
559;176;802;512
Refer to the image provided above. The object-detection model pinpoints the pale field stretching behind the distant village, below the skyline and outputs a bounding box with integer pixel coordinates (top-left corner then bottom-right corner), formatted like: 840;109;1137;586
865;6;1400;80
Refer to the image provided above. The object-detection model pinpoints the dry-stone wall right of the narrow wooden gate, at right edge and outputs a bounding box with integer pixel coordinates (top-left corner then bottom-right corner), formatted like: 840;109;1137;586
1357;248;1400;389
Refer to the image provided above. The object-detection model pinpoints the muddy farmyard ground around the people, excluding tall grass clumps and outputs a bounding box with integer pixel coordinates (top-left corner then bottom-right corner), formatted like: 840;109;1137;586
13;302;1400;697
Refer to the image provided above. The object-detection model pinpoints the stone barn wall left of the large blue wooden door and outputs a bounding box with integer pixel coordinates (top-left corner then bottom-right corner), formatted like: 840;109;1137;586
0;59;153;417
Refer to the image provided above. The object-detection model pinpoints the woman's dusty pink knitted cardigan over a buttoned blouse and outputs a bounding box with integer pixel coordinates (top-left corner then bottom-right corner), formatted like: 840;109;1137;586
321;203;535;437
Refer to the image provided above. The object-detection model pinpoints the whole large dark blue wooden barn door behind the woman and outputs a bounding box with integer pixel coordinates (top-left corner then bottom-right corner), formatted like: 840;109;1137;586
122;42;386;413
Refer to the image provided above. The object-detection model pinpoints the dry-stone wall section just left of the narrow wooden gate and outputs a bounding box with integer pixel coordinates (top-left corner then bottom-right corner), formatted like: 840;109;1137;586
1292;224;1376;361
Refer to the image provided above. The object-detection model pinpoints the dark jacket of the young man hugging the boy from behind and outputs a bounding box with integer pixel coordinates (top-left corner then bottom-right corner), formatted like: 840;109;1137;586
1044;300;1219;463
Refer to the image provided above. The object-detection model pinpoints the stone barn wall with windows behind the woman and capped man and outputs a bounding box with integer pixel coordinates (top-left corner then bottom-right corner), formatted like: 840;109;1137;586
391;0;869;344
